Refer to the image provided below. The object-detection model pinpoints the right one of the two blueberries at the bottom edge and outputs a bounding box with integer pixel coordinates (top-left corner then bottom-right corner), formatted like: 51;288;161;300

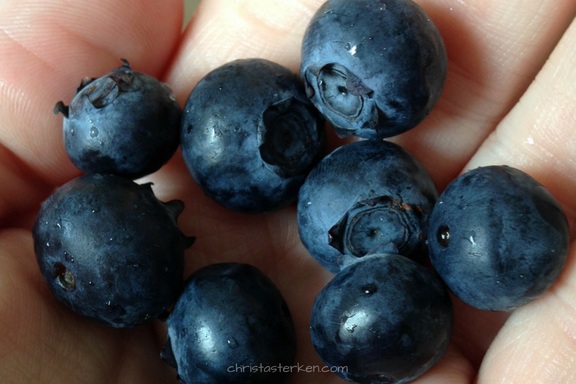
310;254;454;384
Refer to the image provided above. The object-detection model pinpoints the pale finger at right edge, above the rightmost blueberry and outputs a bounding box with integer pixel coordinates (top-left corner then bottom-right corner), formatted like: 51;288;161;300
466;15;576;238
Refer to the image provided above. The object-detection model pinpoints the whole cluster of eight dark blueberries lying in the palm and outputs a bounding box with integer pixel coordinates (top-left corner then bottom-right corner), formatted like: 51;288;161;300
33;0;569;384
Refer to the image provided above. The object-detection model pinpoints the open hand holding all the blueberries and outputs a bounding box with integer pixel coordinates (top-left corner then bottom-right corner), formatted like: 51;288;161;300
0;0;576;384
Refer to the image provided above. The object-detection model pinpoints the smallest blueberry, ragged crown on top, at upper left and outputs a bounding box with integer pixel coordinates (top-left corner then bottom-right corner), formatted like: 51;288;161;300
54;60;182;179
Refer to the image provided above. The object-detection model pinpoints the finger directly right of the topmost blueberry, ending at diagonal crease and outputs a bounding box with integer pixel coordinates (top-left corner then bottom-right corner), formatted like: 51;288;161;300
395;0;576;189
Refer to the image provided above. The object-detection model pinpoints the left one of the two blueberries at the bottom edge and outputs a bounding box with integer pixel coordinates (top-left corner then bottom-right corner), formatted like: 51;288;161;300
161;263;296;384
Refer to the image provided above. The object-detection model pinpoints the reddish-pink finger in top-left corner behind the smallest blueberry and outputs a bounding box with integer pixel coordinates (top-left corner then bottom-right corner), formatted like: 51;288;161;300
0;0;183;222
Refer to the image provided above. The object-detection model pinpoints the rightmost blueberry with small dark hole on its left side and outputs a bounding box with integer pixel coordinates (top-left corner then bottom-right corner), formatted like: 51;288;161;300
428;166;569;311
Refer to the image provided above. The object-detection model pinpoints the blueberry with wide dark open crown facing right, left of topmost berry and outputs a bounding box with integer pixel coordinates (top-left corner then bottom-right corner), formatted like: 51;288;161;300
181;59;326;214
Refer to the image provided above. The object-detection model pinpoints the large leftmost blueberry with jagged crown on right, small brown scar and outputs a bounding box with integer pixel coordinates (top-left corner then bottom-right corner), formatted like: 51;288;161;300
32;175;194;328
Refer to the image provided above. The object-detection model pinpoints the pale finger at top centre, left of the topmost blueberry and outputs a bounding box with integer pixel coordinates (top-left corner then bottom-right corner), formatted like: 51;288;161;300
167;0;324;102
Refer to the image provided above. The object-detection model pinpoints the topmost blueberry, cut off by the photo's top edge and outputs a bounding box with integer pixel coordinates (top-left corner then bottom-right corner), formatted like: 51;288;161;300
300;0;448;139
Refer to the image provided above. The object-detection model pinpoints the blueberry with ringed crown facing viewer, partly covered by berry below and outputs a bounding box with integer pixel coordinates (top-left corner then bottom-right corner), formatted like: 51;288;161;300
298;140;438;273
